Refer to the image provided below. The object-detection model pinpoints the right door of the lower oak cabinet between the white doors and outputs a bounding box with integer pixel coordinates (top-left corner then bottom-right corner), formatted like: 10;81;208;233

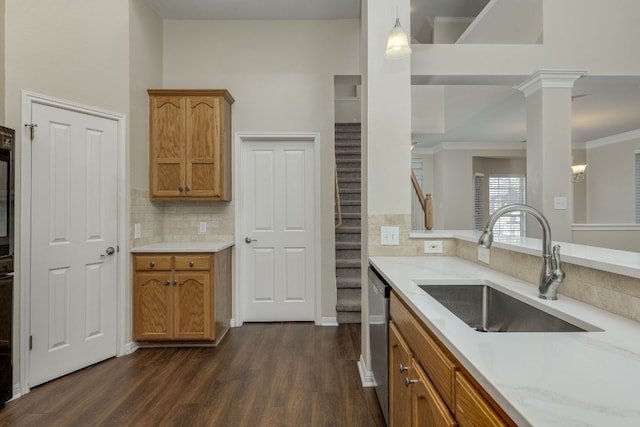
173;271;215;340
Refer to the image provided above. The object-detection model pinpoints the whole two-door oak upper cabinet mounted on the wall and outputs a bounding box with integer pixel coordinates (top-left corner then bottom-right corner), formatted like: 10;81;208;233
148;89;234;201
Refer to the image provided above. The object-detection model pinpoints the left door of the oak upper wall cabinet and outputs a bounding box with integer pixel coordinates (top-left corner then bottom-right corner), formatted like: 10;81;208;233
149;96;186;198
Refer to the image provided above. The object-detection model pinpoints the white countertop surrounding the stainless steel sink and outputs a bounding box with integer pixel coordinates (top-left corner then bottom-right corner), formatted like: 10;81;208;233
370;256;640;426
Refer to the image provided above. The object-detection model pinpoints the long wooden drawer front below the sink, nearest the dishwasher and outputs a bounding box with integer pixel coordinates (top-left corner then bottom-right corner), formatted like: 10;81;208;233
391;293;457;411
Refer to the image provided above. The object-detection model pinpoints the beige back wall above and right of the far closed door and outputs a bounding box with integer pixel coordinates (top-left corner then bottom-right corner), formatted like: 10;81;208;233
163;20;360;317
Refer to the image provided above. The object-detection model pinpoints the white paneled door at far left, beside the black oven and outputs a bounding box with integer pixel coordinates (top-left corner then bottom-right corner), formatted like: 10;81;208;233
28;103;118;387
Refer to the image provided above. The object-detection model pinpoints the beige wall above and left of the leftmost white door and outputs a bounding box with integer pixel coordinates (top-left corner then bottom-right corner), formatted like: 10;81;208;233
4;0;129;396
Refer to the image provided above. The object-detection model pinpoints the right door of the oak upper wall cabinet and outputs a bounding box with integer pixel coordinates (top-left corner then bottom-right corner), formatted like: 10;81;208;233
186;96;222;197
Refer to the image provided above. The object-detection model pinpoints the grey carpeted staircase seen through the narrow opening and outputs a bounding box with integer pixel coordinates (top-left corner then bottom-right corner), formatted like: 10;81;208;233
335;123;361;323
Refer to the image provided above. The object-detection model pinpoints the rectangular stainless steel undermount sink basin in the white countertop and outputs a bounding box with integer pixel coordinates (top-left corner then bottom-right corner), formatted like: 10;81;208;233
416;281;601;332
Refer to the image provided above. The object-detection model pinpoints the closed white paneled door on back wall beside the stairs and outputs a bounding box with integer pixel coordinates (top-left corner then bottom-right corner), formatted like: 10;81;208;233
238;140;316;322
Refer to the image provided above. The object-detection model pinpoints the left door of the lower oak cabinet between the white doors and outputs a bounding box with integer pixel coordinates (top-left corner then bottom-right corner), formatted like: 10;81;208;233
133;271;172;341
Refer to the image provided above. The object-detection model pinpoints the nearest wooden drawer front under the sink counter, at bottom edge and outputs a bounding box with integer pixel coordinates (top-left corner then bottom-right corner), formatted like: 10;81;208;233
455;372;507;427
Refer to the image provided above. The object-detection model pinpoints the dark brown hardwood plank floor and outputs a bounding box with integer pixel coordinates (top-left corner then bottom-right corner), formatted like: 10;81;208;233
0;323;385;427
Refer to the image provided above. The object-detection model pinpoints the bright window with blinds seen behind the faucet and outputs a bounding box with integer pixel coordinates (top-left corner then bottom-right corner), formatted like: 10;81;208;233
489;175;526;237
